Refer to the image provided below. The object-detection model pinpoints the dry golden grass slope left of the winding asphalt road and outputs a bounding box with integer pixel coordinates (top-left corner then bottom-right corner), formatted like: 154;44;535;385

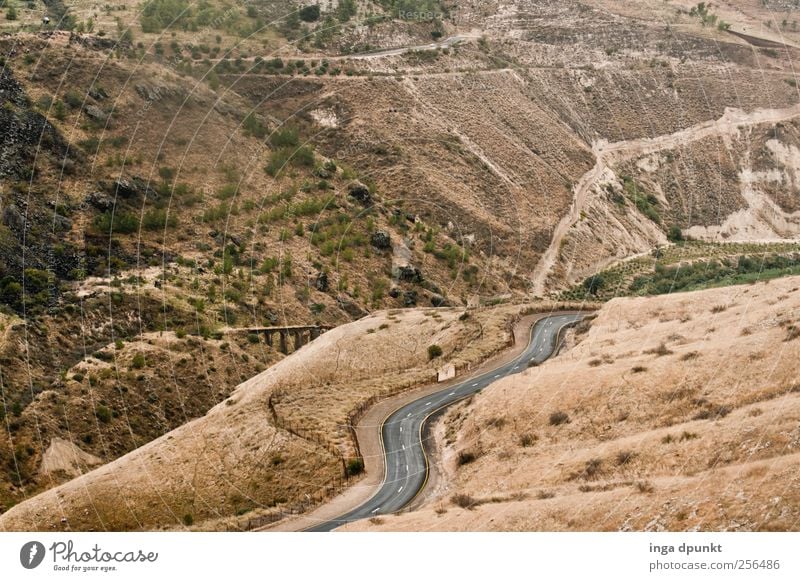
0;307;536;530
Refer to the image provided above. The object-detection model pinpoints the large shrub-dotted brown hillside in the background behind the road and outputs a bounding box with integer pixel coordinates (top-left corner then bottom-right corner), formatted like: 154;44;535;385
0;0;800;526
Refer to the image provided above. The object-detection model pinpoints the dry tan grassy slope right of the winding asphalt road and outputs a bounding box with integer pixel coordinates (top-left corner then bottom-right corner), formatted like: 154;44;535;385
349;277;800;531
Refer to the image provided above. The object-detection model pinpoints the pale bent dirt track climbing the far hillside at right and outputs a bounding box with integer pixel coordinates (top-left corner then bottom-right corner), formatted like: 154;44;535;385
532;104;800;296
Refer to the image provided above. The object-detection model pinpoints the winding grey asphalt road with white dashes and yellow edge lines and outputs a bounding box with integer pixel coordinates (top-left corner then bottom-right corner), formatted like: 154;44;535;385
305;313;586;532
